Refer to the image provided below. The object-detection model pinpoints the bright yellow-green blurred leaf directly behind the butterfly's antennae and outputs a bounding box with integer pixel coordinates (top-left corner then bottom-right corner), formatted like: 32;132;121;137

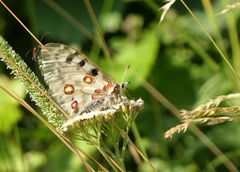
105;26;159;88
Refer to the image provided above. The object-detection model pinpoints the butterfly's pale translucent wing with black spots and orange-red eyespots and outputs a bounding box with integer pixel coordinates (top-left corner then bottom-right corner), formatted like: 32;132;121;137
38;43;115;116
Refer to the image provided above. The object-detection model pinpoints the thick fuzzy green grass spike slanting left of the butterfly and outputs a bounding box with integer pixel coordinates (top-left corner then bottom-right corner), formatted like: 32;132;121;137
0;37;64;127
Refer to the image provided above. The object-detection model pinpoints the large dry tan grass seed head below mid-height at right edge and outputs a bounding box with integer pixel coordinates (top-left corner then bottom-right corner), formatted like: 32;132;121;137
164;93;240;138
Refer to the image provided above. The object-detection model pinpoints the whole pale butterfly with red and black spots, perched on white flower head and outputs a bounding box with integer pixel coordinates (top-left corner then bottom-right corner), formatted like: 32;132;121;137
37;43;143;130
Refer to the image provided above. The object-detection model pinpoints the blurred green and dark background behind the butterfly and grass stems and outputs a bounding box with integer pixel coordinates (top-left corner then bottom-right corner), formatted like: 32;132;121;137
0;0;240;172
